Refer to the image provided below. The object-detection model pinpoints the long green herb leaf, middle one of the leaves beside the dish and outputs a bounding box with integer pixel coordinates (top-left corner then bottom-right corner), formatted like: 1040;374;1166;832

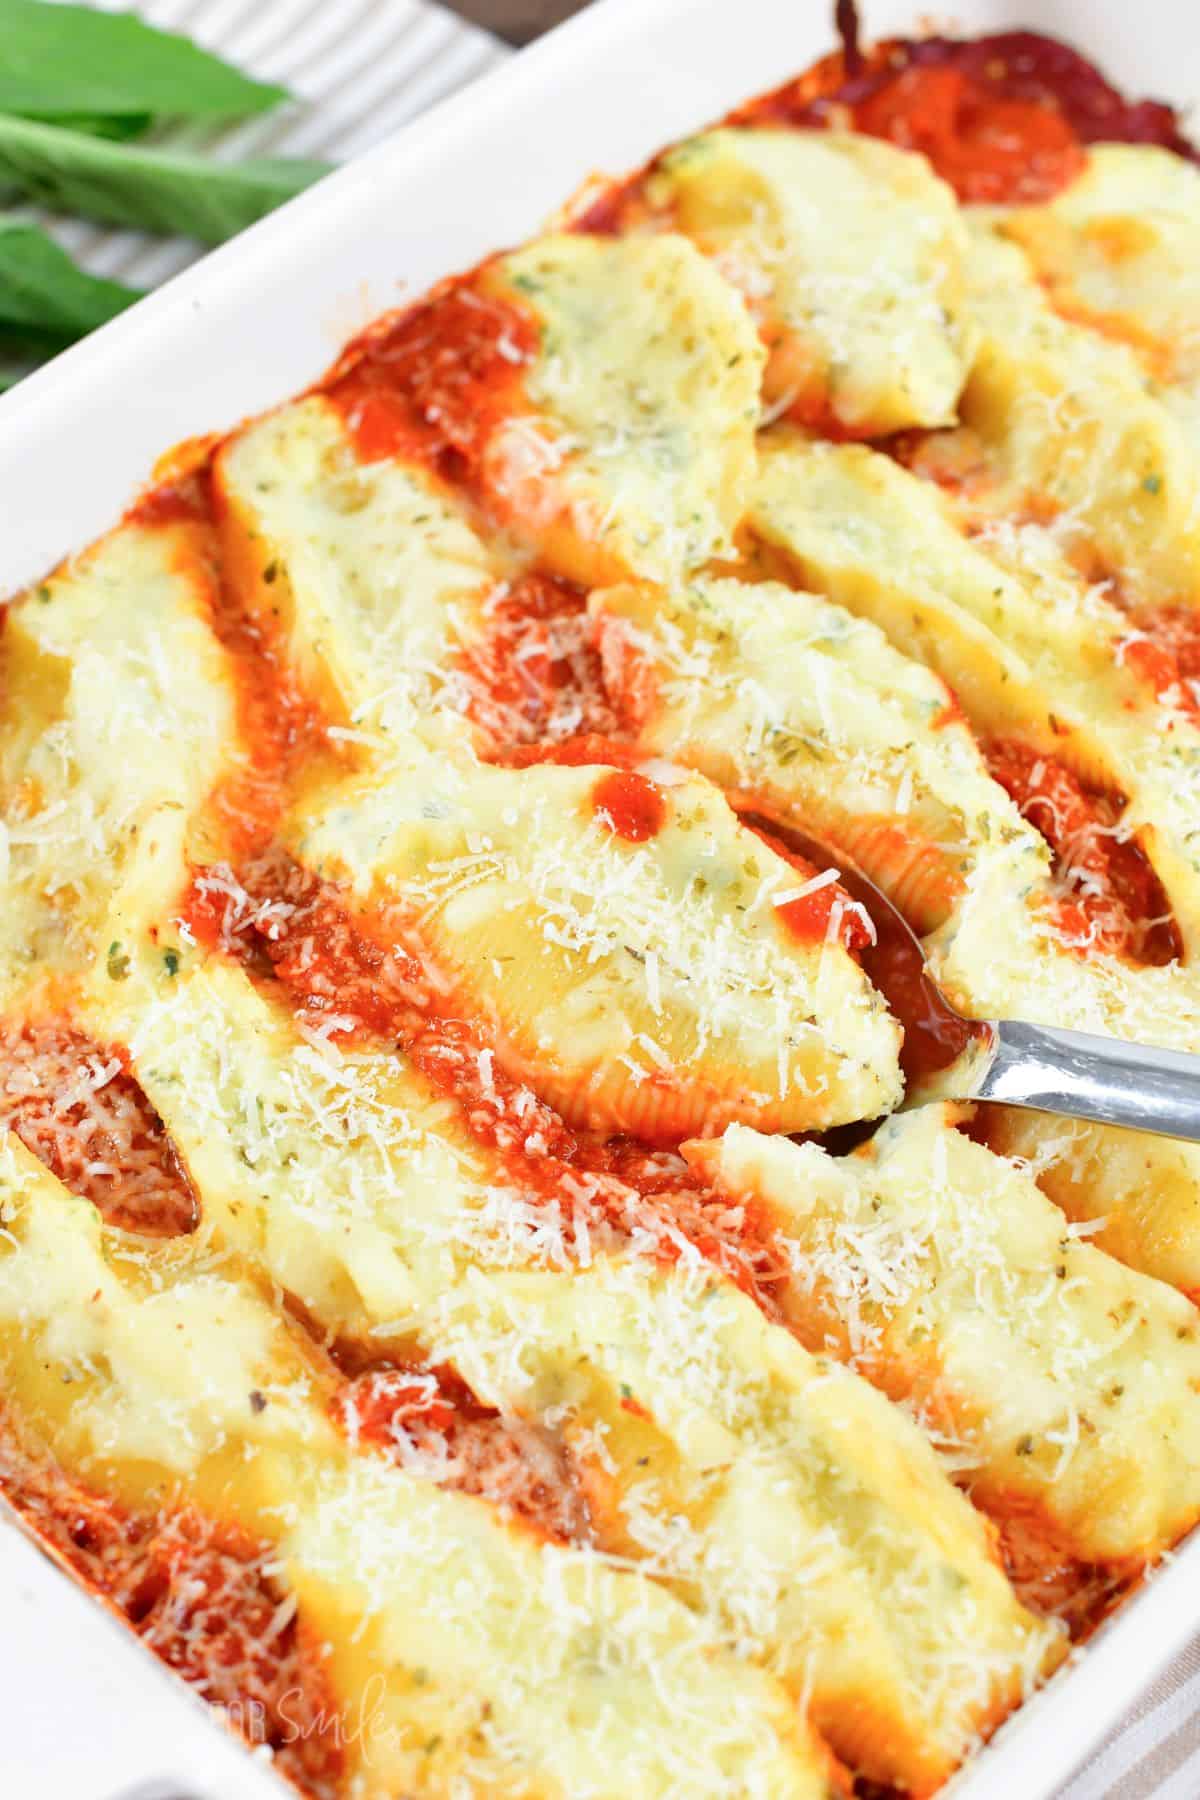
0;114;327;243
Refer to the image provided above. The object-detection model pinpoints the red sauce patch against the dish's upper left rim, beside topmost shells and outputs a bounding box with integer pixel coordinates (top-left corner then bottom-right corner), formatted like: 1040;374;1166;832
327;275;538;472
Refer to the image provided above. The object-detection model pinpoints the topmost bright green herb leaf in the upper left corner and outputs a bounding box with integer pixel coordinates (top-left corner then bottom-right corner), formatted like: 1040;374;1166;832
0;0;288;119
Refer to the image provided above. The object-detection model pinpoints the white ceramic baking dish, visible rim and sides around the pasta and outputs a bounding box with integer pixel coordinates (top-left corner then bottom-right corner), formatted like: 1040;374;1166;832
0;0;1200;1800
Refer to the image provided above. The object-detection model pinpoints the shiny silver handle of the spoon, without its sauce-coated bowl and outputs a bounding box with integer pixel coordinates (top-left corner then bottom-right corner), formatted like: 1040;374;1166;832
961;1019;1200;1143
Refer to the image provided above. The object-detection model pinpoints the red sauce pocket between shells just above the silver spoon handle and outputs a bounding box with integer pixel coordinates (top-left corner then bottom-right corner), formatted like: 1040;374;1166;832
986;738;1182;965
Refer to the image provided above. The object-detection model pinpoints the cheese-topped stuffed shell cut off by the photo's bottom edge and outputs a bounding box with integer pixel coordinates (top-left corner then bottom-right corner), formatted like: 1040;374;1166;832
286;1460;844;1800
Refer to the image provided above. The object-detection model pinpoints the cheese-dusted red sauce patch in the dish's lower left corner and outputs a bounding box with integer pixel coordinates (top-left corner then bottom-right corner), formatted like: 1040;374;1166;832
0;1420;345;1800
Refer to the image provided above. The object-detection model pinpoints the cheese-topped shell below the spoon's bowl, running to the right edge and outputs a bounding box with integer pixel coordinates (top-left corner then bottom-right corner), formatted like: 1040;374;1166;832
689;1107;1200;1561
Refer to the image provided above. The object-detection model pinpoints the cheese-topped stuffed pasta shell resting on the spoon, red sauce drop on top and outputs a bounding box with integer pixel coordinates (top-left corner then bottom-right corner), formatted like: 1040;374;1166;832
293;763;898;1138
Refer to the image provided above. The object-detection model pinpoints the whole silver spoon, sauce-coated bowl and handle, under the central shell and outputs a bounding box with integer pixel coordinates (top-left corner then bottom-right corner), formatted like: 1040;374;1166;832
761;819;1200;1143
